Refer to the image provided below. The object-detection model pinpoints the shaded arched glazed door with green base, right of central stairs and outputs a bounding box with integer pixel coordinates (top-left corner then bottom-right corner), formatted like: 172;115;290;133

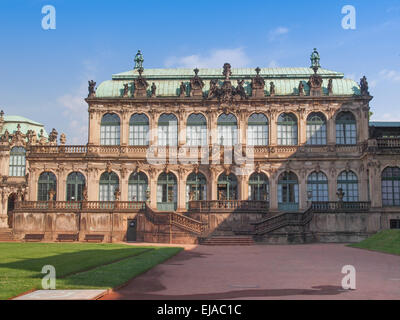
278;172;299;211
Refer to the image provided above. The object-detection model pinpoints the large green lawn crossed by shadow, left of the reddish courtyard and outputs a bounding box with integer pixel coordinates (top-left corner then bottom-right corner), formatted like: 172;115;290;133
0;243;182;299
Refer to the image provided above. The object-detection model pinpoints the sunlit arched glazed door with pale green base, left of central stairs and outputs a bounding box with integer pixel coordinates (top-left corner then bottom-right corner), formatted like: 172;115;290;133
157;173;178;211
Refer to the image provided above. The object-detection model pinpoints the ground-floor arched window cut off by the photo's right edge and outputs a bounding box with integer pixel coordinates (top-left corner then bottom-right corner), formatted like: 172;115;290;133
382;167;400;207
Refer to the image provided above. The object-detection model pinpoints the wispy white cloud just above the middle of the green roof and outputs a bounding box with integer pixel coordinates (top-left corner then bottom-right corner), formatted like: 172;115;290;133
165;48;250;68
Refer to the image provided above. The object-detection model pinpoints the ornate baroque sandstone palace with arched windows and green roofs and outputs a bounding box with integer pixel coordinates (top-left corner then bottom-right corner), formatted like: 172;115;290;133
0;49;400;243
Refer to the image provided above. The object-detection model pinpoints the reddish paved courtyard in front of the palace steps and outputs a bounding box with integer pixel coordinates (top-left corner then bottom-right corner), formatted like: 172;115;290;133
103;244;400;300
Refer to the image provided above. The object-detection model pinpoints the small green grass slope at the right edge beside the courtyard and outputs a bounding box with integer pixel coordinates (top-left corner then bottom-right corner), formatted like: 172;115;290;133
349;230;400;255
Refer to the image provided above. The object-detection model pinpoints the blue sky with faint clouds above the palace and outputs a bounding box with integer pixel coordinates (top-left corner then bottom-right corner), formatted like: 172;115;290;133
0;0;400;144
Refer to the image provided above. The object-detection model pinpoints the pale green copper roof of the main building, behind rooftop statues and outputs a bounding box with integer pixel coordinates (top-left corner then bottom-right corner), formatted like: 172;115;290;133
96;68;360;98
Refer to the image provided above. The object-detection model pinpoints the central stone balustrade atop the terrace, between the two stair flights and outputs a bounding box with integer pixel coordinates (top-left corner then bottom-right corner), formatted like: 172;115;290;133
189;200;269;212
